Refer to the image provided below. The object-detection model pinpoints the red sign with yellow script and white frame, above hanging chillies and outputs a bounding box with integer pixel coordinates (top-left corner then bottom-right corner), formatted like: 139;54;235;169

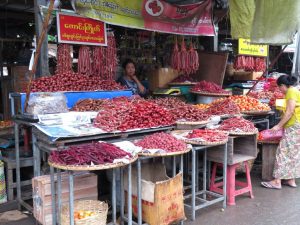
57;13;107;46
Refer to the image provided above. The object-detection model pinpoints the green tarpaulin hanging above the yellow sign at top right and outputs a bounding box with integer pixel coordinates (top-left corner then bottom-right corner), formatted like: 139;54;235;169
229;0;300;45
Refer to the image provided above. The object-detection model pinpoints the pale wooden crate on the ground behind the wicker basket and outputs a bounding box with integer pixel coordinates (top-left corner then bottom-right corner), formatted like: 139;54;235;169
32;173;98;225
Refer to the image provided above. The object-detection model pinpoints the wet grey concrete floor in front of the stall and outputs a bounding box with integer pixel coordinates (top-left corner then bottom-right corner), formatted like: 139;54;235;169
0;174;300;225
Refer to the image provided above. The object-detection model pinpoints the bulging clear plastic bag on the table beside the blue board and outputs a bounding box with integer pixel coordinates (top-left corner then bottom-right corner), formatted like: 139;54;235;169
26;93;69;115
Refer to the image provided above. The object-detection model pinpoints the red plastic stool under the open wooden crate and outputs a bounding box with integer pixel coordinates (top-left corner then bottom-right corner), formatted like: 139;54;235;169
210;161;254;205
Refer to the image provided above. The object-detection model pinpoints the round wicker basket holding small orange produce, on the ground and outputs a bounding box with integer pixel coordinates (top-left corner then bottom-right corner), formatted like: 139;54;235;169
61;200;108;225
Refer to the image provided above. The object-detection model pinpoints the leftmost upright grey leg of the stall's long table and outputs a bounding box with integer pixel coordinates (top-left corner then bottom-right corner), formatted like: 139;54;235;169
14;123;22;210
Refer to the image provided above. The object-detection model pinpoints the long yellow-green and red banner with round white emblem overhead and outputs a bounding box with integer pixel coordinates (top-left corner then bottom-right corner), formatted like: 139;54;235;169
74;0;215;36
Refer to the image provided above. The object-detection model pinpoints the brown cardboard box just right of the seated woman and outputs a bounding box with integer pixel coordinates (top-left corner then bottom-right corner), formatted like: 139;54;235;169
148;68;179;91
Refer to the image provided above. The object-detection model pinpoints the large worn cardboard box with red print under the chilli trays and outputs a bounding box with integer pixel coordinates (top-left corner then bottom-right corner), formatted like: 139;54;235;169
124;163;185;225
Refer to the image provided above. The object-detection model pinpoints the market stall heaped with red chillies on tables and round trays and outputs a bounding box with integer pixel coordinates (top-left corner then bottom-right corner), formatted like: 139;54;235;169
0;0;288;225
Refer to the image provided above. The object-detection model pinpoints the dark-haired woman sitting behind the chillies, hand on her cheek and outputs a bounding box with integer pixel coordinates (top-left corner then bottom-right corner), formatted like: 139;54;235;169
118;59;147;97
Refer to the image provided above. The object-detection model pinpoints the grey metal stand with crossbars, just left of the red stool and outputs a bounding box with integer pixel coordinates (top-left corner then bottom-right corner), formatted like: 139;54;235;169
185;143;227;220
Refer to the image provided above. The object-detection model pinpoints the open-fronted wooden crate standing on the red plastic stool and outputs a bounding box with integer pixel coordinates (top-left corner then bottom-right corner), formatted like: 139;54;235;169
207;135;257;165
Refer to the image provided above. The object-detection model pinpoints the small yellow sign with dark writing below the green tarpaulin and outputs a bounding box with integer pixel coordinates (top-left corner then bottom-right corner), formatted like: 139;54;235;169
239;38;268;57
